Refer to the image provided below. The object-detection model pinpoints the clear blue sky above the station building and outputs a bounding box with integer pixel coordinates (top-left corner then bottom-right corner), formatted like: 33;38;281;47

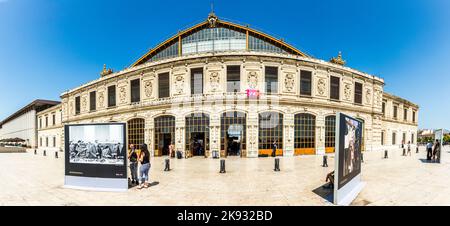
0;0;450;128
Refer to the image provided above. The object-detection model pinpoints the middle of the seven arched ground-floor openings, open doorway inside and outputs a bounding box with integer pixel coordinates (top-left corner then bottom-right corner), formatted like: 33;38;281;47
220;111;247;156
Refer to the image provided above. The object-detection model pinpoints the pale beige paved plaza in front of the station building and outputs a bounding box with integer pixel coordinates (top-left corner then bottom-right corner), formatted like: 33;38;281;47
0;147;450;206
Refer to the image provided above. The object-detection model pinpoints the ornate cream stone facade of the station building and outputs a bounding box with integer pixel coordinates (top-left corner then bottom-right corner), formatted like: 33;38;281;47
61;51;419;157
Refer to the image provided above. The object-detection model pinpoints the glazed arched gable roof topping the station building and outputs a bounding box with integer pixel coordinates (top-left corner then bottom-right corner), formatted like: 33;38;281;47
132;14;308;67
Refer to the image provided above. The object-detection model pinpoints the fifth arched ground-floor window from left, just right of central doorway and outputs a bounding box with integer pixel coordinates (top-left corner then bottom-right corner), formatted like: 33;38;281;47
258;112;283;155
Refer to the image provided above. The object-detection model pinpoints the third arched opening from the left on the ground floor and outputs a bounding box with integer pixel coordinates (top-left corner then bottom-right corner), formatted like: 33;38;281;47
186;113;209;156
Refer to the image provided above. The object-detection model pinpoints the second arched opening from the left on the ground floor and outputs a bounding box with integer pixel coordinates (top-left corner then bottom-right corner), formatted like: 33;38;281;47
154;115;175;156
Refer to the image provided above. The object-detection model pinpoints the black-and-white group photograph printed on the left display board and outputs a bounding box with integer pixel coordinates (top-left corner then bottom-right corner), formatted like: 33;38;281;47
68;124;126;165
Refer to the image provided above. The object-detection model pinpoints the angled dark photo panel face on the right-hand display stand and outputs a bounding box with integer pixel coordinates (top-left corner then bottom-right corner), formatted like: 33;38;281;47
338;114;363;188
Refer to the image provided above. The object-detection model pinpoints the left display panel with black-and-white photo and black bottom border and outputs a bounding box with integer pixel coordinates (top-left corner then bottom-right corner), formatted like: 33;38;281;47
64;123;127;179
